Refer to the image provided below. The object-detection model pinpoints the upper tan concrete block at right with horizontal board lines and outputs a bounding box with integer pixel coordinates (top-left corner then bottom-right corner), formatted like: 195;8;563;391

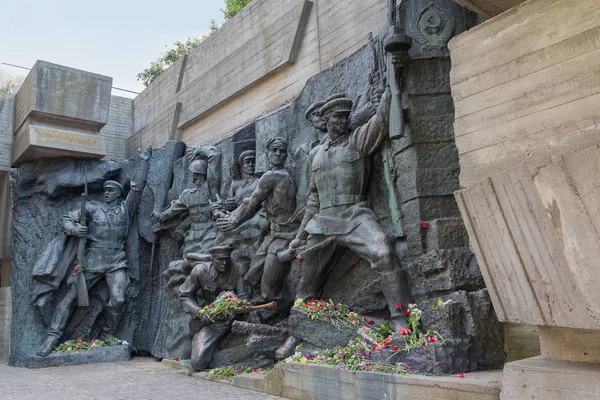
450;0;600;187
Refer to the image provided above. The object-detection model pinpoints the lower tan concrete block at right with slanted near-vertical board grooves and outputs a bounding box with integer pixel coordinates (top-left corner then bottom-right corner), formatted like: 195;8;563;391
457;152;600;329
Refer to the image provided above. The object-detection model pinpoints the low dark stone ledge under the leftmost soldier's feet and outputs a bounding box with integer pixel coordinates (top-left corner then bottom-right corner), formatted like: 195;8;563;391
14;344;133;368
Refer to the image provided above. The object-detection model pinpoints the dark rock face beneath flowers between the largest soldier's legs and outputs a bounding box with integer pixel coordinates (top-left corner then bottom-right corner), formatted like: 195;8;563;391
287;307;356;349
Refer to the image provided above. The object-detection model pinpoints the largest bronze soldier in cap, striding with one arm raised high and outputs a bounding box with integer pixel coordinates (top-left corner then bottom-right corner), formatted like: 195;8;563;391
290;89;408;338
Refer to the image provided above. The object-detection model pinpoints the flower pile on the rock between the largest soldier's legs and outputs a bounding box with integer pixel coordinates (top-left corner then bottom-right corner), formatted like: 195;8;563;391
294;298;364;329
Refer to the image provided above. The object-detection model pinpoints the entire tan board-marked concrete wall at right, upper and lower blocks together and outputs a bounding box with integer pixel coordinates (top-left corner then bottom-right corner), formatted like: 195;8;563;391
450;0;600;329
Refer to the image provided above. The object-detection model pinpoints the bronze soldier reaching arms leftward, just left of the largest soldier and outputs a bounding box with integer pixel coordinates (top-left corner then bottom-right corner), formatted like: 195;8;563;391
217;137;296;299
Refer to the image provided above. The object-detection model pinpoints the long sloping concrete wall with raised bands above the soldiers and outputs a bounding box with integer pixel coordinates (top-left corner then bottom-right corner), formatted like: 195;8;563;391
128;0;387;155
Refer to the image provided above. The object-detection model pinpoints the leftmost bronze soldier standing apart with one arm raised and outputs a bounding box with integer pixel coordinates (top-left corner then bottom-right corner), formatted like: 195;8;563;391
37;147;152;356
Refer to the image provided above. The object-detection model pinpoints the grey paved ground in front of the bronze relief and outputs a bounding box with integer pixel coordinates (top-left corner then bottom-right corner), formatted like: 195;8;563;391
0;358;283;400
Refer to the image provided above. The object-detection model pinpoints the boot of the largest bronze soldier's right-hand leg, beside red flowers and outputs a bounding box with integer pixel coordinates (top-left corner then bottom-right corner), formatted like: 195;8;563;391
380;271;410;347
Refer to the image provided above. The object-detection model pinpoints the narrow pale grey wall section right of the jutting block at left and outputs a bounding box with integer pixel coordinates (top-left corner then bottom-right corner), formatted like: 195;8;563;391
100;96;133;161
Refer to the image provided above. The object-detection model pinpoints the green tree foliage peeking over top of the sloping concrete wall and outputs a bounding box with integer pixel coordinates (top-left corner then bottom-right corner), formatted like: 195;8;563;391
136;0;252;86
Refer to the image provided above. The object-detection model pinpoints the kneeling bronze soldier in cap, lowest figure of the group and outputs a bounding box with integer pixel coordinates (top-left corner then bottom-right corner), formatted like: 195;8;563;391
179;246;248;371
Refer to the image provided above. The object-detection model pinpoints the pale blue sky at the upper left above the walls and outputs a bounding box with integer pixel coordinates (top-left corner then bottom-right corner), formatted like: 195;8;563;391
0;0;225;97
